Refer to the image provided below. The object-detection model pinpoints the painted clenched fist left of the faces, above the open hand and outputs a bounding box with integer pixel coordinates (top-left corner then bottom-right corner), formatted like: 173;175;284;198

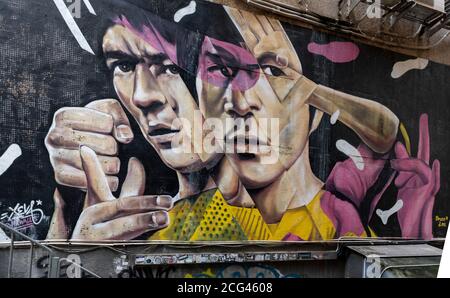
45;99;134;191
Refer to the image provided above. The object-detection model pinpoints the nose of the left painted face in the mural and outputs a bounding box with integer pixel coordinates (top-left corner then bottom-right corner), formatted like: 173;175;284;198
133;63;166;110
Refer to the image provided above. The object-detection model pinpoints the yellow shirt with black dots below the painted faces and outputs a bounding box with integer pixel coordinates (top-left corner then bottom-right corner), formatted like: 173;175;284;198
149;190;365;241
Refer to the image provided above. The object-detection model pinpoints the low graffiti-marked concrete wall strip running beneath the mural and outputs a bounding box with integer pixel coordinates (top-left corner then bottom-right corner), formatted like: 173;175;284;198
0;241;443;278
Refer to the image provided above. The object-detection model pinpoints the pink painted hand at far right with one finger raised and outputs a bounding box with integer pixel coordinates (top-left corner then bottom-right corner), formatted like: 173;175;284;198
391;114;440;239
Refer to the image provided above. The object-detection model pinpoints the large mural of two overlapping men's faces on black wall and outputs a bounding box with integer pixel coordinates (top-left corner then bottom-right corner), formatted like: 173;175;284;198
0;0;450;241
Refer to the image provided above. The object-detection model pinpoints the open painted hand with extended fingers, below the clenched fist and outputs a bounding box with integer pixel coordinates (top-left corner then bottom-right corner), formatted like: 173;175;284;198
72;146;173;240
